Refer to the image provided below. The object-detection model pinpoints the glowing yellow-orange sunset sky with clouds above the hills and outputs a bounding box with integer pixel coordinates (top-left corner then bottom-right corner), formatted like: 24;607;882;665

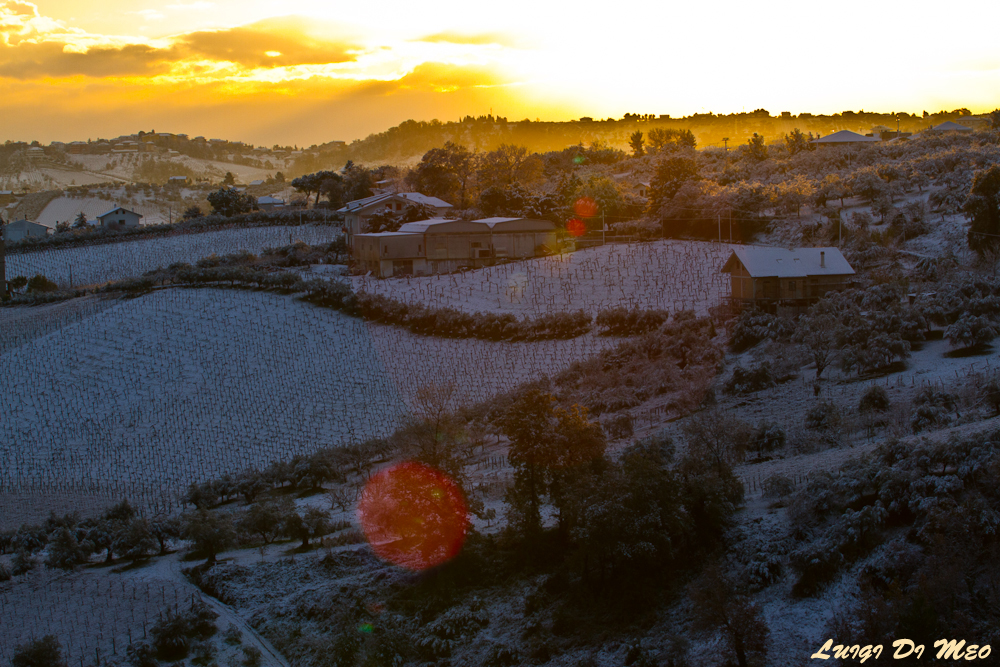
0;0;1000;146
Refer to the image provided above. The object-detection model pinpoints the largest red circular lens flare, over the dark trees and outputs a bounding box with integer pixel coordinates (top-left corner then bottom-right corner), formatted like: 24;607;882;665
358;461;469;570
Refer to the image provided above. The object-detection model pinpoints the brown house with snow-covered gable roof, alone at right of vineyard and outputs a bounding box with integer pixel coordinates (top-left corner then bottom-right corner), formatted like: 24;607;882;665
722;246;854;307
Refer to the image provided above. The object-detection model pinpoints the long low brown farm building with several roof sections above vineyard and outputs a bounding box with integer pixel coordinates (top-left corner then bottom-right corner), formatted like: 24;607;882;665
353;218;558;278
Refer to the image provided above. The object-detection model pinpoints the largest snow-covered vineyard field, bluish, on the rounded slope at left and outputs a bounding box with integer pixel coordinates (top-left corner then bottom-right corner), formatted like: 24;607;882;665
0;289;614;526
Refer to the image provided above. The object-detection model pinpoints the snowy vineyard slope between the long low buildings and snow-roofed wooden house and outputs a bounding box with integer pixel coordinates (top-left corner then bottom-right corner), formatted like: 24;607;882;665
354;241;732;316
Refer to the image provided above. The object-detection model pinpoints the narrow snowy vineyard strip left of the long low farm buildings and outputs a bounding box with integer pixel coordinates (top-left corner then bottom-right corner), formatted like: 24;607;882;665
7;224;340;287
